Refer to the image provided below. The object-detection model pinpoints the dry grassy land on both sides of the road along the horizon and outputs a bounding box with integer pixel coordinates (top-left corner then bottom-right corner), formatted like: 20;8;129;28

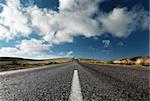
0;56;150;71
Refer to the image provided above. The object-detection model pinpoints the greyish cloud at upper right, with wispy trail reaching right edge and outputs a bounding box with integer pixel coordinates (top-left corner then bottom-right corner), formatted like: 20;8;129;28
99;8;149;38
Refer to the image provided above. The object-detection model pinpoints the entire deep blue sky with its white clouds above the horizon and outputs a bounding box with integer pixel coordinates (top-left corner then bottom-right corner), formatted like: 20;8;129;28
0;0;149;60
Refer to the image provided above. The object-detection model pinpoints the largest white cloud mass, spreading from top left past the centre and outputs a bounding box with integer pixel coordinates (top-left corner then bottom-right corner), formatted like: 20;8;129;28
0;0;102;44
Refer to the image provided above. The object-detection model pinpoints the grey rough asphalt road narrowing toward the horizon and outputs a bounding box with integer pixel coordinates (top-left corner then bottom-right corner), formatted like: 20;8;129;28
0;62;150;101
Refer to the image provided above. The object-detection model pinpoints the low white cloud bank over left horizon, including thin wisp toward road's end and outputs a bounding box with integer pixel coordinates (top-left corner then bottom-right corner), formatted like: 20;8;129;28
0;39;73;59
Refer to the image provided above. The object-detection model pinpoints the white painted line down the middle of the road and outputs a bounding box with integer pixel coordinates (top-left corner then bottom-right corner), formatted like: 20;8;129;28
69;70;83;101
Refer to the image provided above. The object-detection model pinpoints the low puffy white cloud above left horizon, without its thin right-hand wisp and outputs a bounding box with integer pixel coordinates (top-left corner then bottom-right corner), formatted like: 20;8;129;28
0;39;51;58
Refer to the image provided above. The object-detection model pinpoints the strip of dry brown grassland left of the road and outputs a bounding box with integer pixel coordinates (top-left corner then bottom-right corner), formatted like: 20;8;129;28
0;57;72;71
